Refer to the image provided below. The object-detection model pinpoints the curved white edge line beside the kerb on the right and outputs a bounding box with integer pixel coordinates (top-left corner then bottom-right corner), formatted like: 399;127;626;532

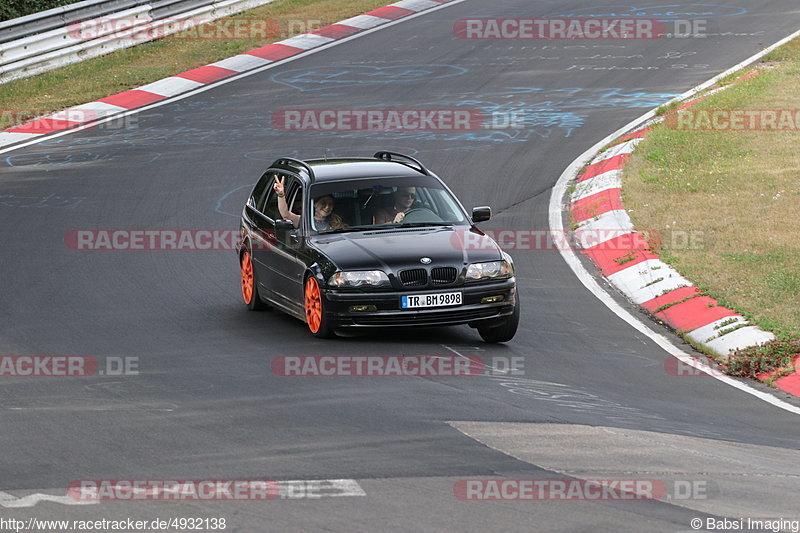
549;27;800;415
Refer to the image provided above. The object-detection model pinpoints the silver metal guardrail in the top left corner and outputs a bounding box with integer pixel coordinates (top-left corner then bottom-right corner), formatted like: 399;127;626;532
0;0;273;83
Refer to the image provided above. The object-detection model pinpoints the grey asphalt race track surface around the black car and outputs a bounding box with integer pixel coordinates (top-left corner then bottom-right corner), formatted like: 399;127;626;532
0;0;800;532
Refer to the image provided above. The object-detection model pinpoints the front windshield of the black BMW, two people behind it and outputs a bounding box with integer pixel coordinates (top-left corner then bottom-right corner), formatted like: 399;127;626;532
310;176;467;233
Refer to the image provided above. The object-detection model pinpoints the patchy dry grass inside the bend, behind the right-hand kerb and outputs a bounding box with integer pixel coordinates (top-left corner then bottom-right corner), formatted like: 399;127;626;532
623;40;800;339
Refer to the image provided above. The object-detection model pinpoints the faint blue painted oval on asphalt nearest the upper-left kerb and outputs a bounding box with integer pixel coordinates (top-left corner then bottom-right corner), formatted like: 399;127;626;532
270;65;468;91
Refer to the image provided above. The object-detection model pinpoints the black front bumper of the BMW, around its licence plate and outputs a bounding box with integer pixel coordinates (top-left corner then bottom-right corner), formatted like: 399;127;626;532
323;278;516;328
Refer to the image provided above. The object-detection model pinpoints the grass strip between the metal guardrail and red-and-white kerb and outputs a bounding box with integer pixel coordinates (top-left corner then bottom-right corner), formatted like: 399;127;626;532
0;0;387;130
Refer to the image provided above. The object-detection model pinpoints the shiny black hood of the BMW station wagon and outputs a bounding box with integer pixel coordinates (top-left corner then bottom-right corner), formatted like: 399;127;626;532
312;227;503;273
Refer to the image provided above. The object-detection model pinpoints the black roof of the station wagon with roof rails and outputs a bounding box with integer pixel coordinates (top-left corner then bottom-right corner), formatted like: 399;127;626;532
272;152;430;183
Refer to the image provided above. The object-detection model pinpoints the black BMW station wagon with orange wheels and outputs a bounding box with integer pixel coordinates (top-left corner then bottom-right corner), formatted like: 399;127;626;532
238;152;520;342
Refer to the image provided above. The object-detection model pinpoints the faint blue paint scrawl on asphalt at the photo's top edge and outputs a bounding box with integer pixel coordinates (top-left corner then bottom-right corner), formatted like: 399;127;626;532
555;4;748;20
